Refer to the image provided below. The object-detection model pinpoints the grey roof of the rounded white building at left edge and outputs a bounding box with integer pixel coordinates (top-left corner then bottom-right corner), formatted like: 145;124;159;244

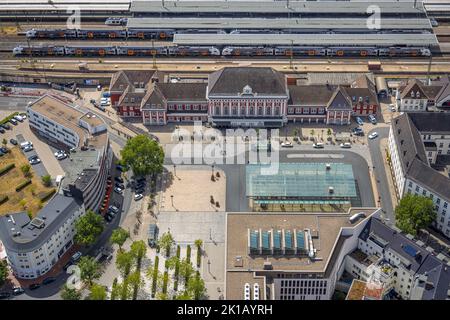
0;194;81;252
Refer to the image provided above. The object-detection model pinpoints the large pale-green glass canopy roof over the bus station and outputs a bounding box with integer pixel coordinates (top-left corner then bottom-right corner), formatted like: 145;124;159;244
246;163;358;207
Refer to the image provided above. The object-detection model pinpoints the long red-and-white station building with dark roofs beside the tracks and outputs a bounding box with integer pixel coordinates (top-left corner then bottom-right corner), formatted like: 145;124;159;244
110;67;378;127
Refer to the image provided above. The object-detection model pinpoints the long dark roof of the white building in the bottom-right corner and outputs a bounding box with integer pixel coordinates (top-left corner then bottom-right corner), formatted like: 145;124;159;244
359;218;450;300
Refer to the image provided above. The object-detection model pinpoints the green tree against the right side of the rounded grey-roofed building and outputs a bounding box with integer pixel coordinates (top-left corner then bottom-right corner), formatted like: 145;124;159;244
75;210;104;246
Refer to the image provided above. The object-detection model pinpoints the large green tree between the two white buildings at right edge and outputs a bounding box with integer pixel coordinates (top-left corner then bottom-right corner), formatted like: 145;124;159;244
395;193;436;235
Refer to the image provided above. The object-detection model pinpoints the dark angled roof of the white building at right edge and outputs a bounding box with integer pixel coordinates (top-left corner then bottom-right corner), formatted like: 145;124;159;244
392;112;450;199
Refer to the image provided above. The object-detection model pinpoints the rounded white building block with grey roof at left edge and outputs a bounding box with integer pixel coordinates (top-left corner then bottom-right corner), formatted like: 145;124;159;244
0;194;84;279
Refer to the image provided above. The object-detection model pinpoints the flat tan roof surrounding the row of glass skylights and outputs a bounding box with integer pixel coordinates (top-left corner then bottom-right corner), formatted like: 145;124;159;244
226;208;377;299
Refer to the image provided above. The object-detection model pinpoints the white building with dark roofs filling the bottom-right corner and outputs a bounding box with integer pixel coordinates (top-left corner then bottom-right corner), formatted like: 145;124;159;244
345;219;450;300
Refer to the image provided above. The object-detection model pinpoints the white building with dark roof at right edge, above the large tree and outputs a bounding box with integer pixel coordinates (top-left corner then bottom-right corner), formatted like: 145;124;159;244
389;113;450;238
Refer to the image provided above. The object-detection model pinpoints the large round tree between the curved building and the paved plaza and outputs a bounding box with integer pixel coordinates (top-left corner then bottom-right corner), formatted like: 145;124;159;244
120;135;164;176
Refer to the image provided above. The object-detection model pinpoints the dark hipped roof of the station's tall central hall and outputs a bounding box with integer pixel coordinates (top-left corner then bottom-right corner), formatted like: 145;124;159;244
208;67;288;96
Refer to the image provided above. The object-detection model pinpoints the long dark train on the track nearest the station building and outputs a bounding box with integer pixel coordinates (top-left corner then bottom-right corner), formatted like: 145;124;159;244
13;46;431;57
